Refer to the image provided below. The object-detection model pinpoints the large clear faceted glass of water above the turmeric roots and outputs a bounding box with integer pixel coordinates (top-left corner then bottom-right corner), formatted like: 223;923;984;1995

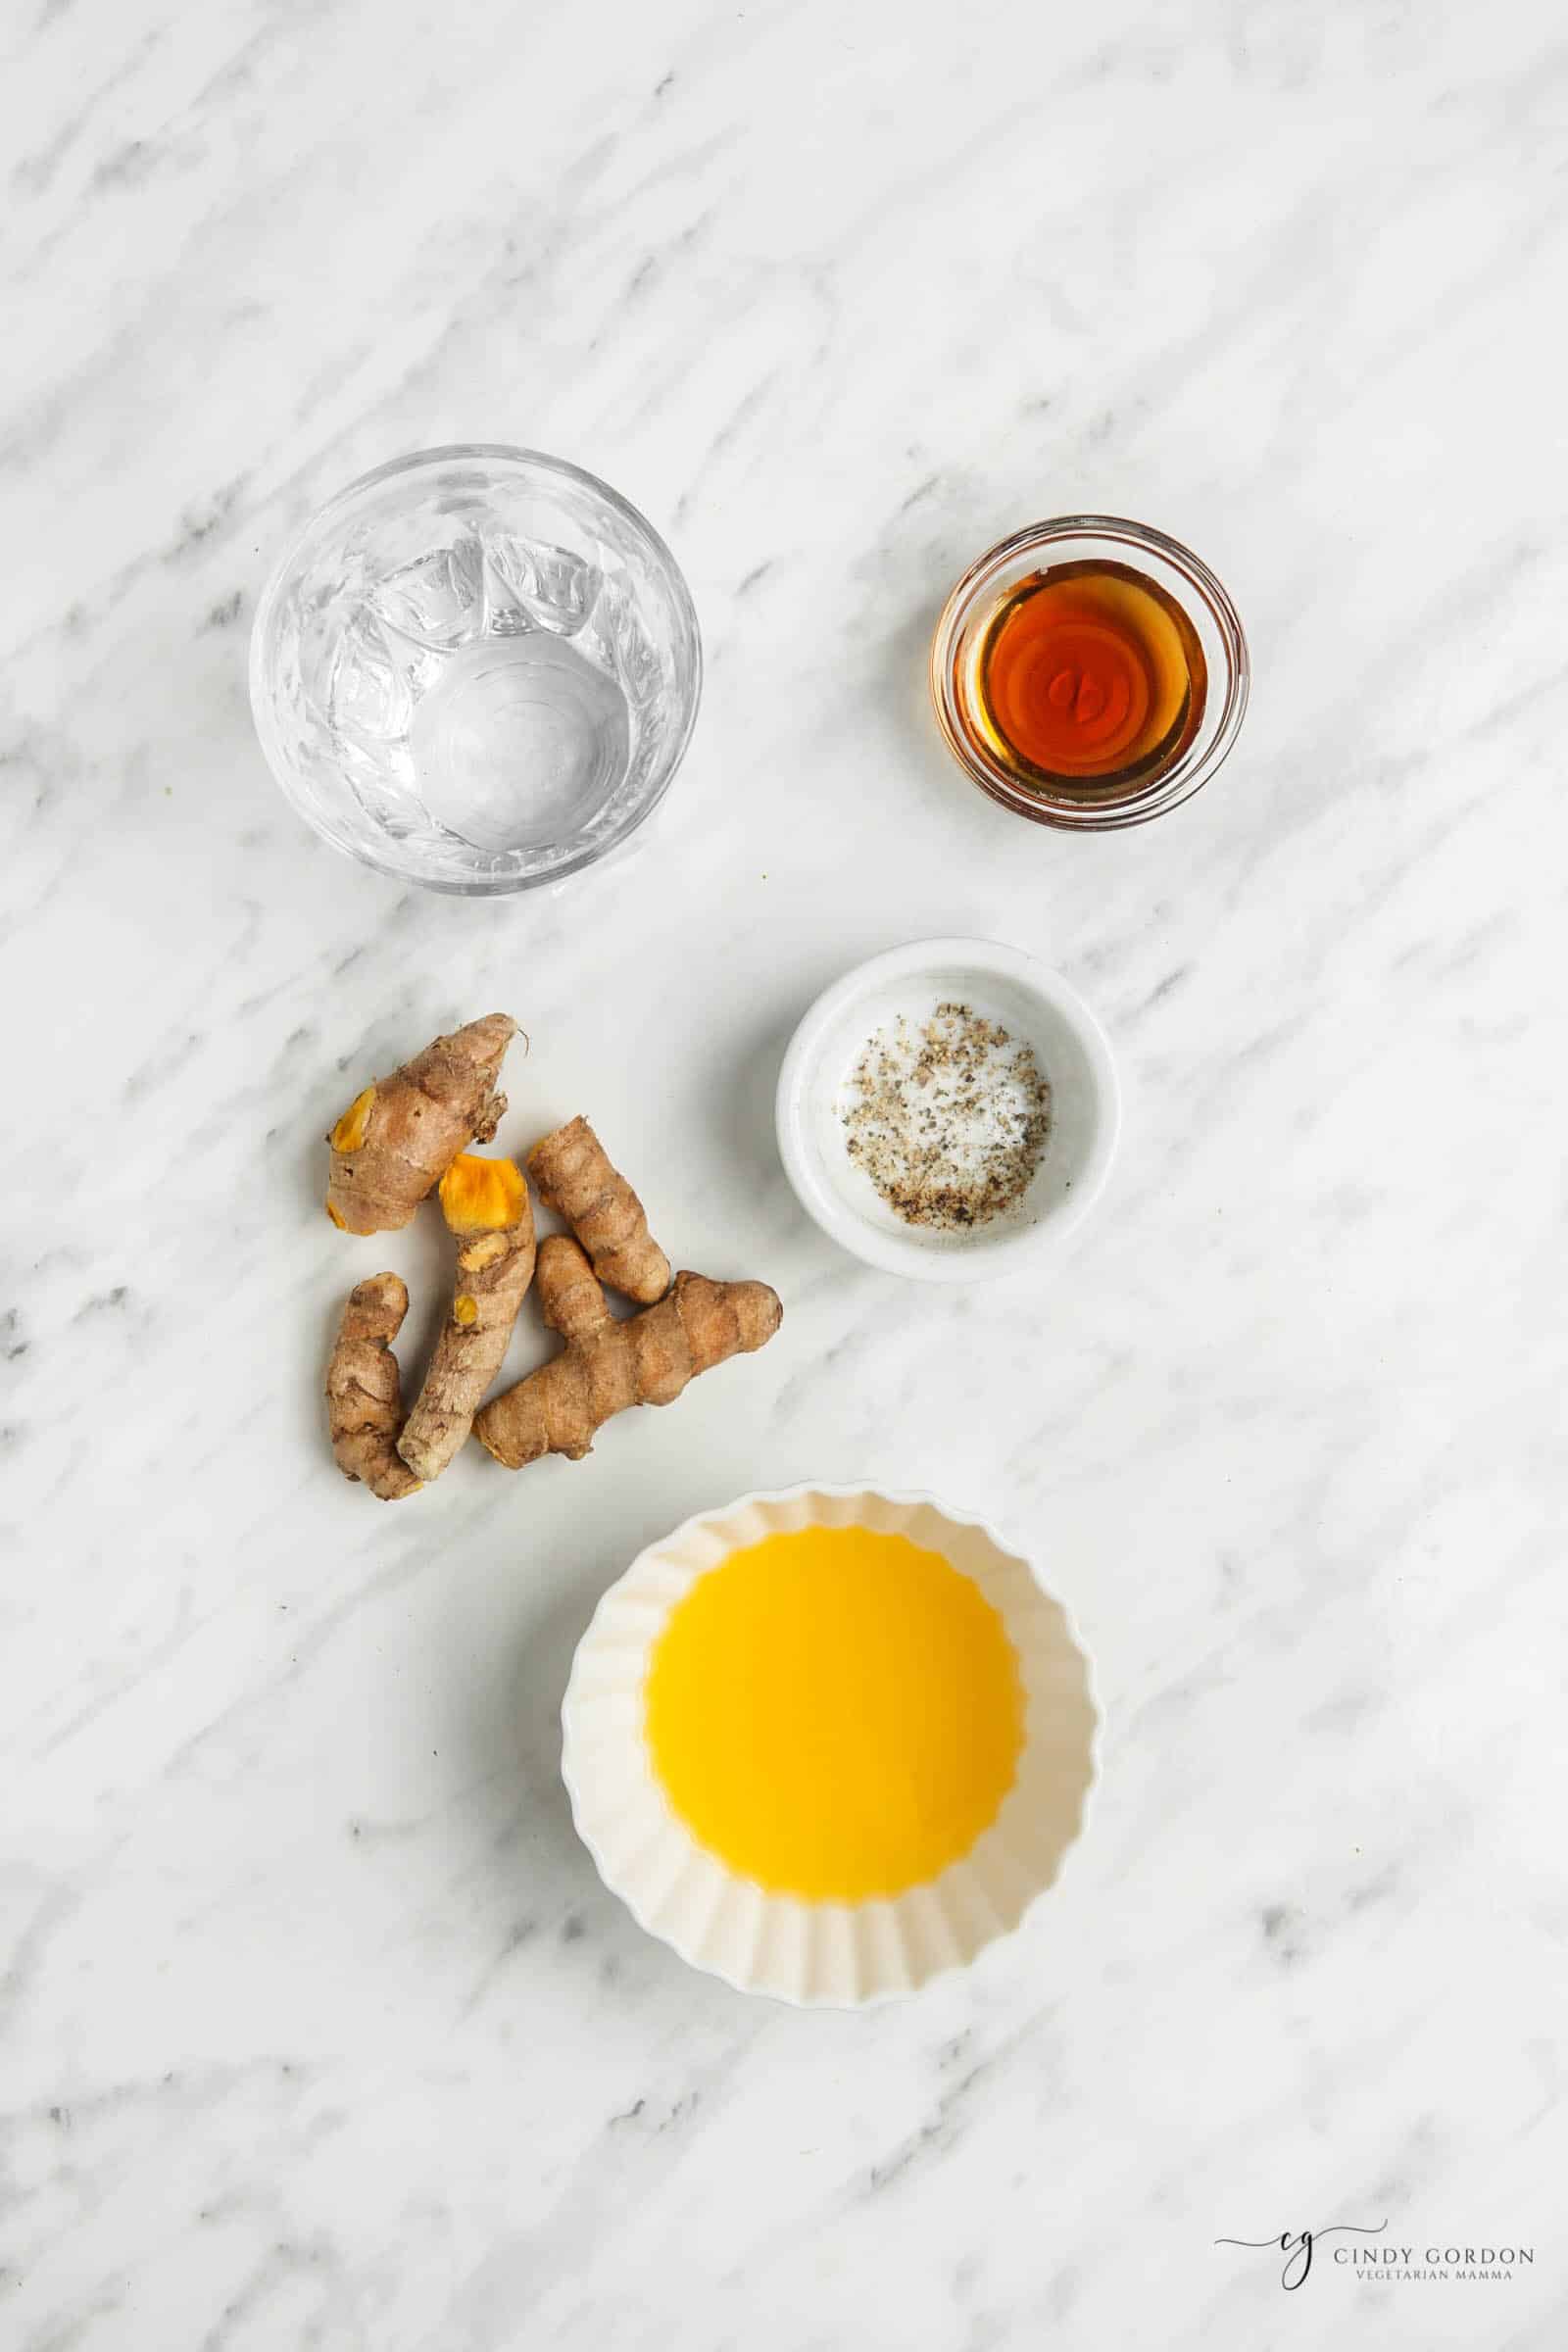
252;442;703;896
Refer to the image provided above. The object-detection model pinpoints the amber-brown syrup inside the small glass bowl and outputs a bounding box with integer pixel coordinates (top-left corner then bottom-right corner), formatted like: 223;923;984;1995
968;560;1208;800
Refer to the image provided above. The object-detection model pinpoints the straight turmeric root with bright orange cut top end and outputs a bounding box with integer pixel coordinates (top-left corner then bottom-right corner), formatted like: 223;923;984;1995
397;1152;534;1484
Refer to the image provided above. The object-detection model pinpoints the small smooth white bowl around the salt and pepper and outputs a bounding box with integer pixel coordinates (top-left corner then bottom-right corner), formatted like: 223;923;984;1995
776;939;1121;1282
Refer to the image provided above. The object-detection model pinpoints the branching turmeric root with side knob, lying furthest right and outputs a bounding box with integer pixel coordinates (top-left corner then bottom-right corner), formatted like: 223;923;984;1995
475;1233;783;1470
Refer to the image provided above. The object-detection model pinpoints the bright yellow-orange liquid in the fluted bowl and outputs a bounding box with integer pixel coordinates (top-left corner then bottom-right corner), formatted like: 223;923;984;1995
647;1527;1025;1903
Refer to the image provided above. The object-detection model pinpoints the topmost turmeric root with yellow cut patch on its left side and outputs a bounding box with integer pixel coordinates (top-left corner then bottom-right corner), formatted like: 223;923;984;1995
326;1013;517;1233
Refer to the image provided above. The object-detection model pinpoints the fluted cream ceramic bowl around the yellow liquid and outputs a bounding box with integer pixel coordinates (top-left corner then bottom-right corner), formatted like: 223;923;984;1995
562;1487;1098;2009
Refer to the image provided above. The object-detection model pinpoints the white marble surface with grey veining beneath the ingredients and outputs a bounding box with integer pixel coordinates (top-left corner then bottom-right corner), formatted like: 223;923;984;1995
0;0;1568;2352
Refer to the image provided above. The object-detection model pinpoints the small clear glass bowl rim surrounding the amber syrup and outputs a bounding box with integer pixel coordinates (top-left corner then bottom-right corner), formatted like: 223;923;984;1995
931;515;1253;833
